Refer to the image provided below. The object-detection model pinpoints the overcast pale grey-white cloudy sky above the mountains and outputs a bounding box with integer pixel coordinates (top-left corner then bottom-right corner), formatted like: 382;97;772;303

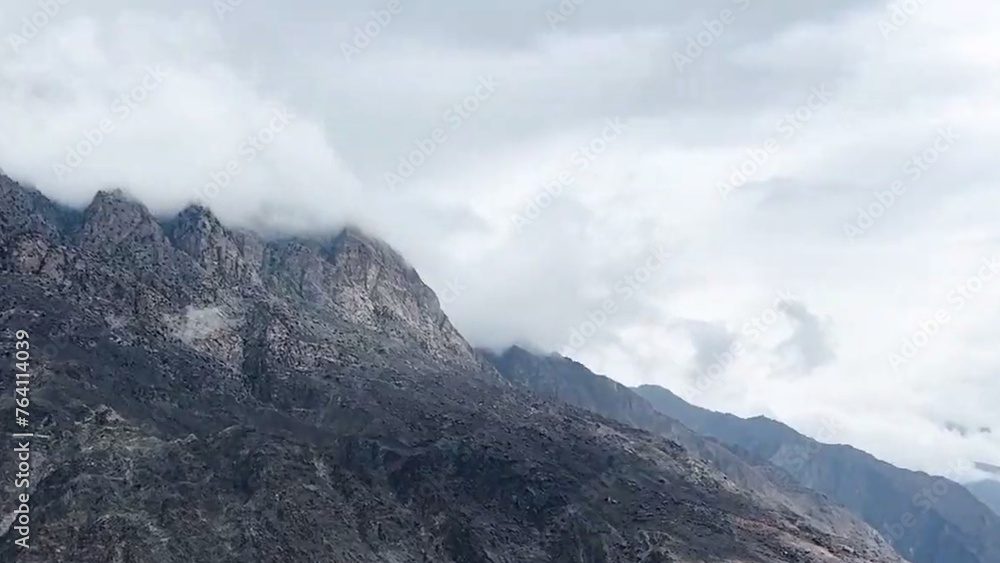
0;0;1000;478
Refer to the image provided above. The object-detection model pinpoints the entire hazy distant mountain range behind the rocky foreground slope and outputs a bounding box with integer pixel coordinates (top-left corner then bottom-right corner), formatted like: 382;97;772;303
485;348;1000;563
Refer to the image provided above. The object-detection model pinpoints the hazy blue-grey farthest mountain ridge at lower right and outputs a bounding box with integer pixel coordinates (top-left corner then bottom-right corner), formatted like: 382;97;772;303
635;386;1000;563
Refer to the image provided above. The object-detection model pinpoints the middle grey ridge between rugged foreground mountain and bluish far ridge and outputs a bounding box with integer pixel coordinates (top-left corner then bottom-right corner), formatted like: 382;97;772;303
480;346;904;557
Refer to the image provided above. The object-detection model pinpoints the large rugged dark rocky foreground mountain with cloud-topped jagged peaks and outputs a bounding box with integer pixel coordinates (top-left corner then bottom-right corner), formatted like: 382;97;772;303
0;176;900;563
